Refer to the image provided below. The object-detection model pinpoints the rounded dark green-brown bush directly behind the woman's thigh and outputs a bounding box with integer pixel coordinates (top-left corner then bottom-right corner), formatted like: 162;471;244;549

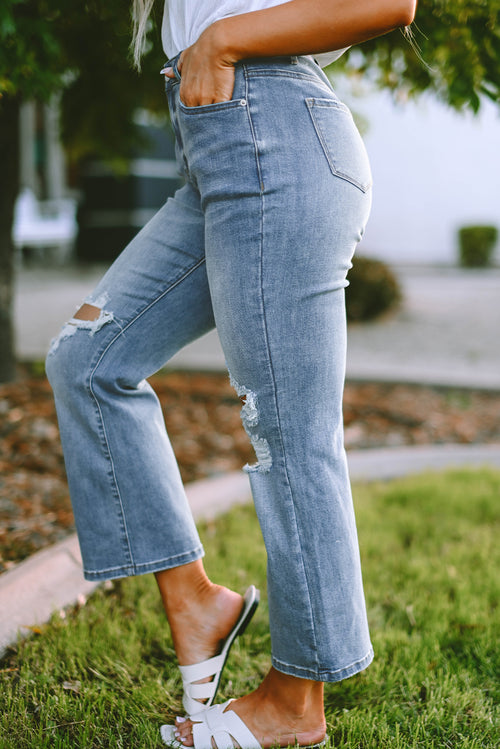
346;255;401;321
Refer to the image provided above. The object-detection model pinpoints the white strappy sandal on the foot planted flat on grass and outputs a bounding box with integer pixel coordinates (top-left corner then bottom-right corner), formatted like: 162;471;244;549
160;700;326;749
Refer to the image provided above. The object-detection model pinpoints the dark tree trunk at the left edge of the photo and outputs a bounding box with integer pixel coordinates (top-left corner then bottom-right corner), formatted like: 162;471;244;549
0;97;20;382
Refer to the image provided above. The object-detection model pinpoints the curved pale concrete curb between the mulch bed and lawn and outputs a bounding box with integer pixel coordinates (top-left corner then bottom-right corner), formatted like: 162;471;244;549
0;444;500;655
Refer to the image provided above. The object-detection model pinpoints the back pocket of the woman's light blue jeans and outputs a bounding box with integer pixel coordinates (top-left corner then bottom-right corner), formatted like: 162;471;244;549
306;98;372;192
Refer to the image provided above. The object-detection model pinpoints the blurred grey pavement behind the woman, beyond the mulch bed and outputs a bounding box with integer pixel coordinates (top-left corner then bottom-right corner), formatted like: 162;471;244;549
15;266;500;390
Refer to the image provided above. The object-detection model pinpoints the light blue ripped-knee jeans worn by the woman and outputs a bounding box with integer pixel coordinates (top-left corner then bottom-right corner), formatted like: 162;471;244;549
47;57;372;681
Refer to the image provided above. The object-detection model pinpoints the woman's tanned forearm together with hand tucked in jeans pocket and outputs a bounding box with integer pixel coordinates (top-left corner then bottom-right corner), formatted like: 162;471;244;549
173;0;417;107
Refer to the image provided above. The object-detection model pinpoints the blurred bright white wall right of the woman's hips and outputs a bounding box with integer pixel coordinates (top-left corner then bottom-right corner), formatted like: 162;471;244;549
346;91;500;264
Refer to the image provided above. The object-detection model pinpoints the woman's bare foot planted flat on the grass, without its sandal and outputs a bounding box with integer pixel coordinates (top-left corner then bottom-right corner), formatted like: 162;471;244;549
176;668;326;747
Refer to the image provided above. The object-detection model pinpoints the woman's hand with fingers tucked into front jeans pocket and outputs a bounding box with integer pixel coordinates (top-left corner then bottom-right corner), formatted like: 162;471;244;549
163;22;234;107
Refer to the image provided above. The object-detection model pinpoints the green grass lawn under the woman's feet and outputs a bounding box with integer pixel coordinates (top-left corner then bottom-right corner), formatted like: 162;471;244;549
0;470;500;749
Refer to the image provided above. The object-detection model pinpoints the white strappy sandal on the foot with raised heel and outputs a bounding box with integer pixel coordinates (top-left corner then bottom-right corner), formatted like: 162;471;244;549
179;585;259;716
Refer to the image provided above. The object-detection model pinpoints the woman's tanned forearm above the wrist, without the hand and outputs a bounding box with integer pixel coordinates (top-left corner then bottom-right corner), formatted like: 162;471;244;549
211;0;416;62
